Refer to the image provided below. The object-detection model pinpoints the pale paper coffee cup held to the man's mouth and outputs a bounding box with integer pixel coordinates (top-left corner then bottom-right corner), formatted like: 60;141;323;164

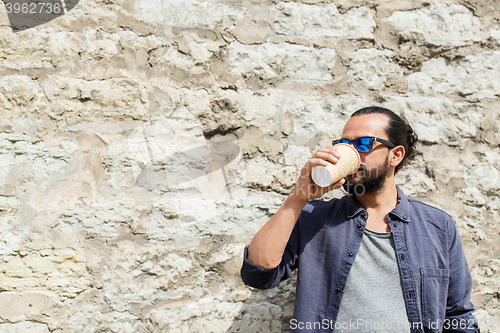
311;143;361;187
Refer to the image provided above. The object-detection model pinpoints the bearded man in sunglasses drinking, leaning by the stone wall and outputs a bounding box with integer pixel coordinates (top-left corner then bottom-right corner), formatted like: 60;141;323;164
241;107;479;333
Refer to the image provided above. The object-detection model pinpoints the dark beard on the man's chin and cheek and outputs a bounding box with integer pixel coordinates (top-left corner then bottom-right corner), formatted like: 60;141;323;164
342;158;389;195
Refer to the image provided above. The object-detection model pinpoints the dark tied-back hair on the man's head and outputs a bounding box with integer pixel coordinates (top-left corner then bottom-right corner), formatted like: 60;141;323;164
351;106;418;173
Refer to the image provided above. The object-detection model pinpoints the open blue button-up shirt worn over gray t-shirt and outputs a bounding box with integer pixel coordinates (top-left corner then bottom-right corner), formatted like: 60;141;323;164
241;188;479;333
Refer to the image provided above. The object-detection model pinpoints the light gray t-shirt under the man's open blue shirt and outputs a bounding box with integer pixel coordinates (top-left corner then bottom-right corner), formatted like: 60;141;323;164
334;229;410;333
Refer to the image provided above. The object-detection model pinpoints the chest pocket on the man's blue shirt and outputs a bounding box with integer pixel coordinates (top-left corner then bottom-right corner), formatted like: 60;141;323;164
420;268;450;332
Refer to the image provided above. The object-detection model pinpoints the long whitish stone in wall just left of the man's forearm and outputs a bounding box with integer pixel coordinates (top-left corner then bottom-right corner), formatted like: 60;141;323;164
143;192;281;245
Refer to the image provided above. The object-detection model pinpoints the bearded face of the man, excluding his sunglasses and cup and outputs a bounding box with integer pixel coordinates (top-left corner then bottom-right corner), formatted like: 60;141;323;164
342;114;389;195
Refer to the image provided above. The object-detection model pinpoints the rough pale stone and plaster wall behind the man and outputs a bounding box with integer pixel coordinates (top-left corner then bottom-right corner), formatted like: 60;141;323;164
0;0;500;333
